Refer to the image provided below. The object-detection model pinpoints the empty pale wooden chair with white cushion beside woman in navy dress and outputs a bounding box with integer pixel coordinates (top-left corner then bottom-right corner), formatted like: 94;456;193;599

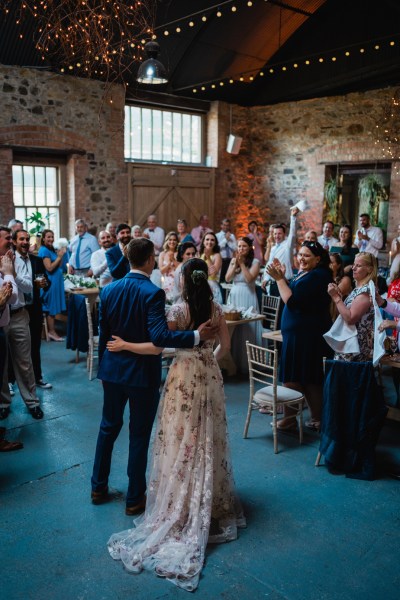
243;342;305;454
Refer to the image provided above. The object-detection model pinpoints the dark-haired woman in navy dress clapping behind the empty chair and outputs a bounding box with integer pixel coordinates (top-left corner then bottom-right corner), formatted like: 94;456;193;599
267;241;332;430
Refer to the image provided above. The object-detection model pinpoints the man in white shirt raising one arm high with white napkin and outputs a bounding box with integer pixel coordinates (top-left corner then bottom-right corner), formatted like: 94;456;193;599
261;208;299;296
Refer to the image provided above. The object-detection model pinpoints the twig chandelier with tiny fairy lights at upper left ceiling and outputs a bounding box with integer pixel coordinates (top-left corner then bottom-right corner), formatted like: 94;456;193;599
0;0;156;82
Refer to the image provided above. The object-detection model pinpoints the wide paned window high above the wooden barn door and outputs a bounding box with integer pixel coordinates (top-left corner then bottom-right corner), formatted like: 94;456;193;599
125;106;202;164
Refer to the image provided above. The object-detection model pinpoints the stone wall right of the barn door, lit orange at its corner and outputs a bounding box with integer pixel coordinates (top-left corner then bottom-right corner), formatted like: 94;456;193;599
215;89;400;244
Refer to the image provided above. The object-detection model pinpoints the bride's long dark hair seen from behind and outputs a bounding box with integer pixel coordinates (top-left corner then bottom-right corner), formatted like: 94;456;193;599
182;258;213;329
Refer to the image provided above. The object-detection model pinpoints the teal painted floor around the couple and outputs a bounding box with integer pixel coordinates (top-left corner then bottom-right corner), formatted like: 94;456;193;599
0;342;400;600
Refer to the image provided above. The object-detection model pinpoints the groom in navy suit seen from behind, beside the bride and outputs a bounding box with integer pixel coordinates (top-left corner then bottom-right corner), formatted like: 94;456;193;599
91;238;215;515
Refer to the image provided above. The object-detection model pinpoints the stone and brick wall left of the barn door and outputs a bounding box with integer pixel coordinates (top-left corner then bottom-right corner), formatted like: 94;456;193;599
0;66;128;236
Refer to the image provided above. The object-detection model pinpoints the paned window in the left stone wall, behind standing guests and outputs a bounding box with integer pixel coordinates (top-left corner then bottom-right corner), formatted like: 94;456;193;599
13;165;60;239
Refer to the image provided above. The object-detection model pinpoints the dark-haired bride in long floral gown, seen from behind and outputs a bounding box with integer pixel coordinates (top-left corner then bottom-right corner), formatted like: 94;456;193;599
107;258;246;591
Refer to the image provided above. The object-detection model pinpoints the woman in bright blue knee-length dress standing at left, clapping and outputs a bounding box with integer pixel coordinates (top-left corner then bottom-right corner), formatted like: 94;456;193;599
38;229;67;342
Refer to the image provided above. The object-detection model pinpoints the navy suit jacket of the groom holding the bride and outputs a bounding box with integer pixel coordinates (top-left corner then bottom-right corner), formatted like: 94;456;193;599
97;272;194;387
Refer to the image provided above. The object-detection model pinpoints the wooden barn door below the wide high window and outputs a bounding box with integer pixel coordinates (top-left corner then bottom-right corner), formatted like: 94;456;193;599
129;164;214;232
